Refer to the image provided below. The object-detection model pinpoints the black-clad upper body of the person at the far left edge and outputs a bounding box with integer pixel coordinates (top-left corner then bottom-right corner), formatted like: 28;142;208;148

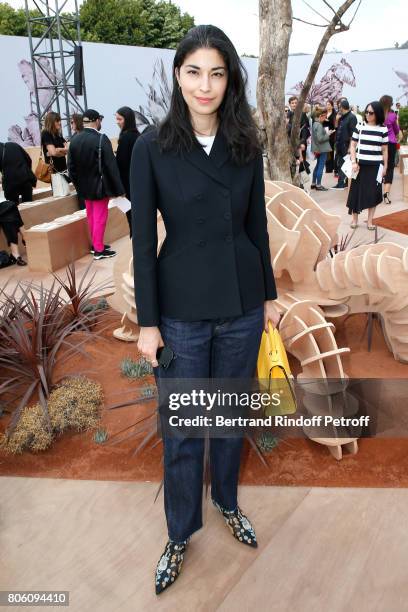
0;142;37;205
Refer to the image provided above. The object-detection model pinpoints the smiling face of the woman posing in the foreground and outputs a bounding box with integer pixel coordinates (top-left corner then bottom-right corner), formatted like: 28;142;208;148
176;48;228;123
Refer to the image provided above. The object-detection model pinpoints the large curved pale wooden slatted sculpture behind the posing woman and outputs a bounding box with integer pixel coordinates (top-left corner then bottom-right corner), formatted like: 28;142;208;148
108;181;408;459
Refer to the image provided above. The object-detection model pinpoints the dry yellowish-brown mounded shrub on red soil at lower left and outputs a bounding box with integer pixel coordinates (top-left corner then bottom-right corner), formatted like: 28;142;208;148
0;376;103;453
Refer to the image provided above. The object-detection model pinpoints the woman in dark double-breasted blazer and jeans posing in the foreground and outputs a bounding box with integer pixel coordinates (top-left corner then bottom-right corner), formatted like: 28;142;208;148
130;26;279;593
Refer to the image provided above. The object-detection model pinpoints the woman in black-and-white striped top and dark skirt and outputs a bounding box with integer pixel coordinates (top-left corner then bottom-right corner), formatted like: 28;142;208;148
347;101;388;230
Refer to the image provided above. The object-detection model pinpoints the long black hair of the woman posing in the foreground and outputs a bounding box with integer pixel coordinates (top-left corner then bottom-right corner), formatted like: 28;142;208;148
158;25;260;165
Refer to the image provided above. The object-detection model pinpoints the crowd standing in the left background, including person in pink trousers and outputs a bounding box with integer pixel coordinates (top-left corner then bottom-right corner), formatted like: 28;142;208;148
0;106;139;267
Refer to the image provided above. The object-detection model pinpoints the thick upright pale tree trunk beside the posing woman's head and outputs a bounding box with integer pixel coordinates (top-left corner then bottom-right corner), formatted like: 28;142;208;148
256;0;292;183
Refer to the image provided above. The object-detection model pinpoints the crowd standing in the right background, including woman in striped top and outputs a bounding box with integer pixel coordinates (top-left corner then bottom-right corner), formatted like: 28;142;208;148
285;95;402;230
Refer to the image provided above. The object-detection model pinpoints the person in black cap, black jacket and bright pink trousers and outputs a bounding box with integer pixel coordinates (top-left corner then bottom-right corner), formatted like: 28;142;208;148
68;109;125;259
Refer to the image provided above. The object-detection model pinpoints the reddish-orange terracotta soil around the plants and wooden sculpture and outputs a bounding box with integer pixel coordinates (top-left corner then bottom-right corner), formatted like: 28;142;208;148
0;308;408;487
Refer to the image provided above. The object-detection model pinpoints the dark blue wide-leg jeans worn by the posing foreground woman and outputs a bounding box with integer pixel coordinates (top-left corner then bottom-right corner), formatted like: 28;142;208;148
154;304;264;542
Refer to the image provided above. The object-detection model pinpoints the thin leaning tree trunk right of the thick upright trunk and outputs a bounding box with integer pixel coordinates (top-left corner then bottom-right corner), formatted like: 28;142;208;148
290;0;356;154
